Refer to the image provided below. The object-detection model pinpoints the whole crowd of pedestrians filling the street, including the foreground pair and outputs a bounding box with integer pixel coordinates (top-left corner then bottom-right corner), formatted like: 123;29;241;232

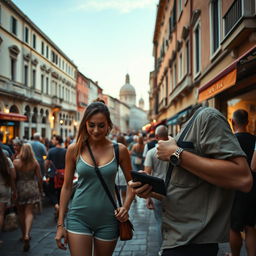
0;99;256;256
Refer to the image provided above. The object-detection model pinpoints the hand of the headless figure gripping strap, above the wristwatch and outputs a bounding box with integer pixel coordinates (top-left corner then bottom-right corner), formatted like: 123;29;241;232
156;137;177;161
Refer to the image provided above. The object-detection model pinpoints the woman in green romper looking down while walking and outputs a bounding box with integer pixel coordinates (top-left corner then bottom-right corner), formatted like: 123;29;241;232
55;101;134;256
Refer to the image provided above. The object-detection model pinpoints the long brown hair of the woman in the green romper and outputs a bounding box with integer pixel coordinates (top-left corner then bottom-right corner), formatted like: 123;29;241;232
75;99;113;158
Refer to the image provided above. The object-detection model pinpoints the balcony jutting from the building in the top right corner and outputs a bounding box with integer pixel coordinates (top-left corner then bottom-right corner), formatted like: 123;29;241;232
222;0;256;49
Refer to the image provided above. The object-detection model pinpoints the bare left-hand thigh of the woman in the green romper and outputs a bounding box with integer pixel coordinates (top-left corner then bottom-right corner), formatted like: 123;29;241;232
68;232;92;256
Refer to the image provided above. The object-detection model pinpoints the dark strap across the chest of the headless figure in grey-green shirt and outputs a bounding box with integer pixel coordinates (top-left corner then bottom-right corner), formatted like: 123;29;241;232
165;107;205;189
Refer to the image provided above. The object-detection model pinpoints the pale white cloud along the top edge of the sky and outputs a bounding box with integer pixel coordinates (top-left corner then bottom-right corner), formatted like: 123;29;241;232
76;0;156;13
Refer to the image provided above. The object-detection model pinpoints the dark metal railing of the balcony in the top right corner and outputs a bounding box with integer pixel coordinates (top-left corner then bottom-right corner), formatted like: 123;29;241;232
223;0;256;36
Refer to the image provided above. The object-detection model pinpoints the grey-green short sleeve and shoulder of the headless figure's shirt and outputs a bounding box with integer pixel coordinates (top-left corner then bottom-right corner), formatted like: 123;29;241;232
198;108;245;159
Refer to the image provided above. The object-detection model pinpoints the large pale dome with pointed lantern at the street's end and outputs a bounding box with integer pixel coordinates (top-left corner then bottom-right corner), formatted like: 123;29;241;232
119;74;136;106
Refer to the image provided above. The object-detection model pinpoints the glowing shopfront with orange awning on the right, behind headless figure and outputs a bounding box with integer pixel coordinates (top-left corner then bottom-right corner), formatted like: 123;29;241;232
198;46;256;134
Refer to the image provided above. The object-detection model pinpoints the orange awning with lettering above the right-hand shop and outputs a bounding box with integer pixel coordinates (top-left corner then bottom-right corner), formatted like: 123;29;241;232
198;46;256;102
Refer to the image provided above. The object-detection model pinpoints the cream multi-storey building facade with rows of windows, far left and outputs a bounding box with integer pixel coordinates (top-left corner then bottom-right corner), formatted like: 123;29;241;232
0;0;77;139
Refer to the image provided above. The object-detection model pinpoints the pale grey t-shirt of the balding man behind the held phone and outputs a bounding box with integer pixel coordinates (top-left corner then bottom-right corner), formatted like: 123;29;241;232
144;147;169;179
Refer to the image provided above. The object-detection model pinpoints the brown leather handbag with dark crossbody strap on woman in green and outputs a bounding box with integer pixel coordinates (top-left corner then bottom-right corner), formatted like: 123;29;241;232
86;141;134;241
